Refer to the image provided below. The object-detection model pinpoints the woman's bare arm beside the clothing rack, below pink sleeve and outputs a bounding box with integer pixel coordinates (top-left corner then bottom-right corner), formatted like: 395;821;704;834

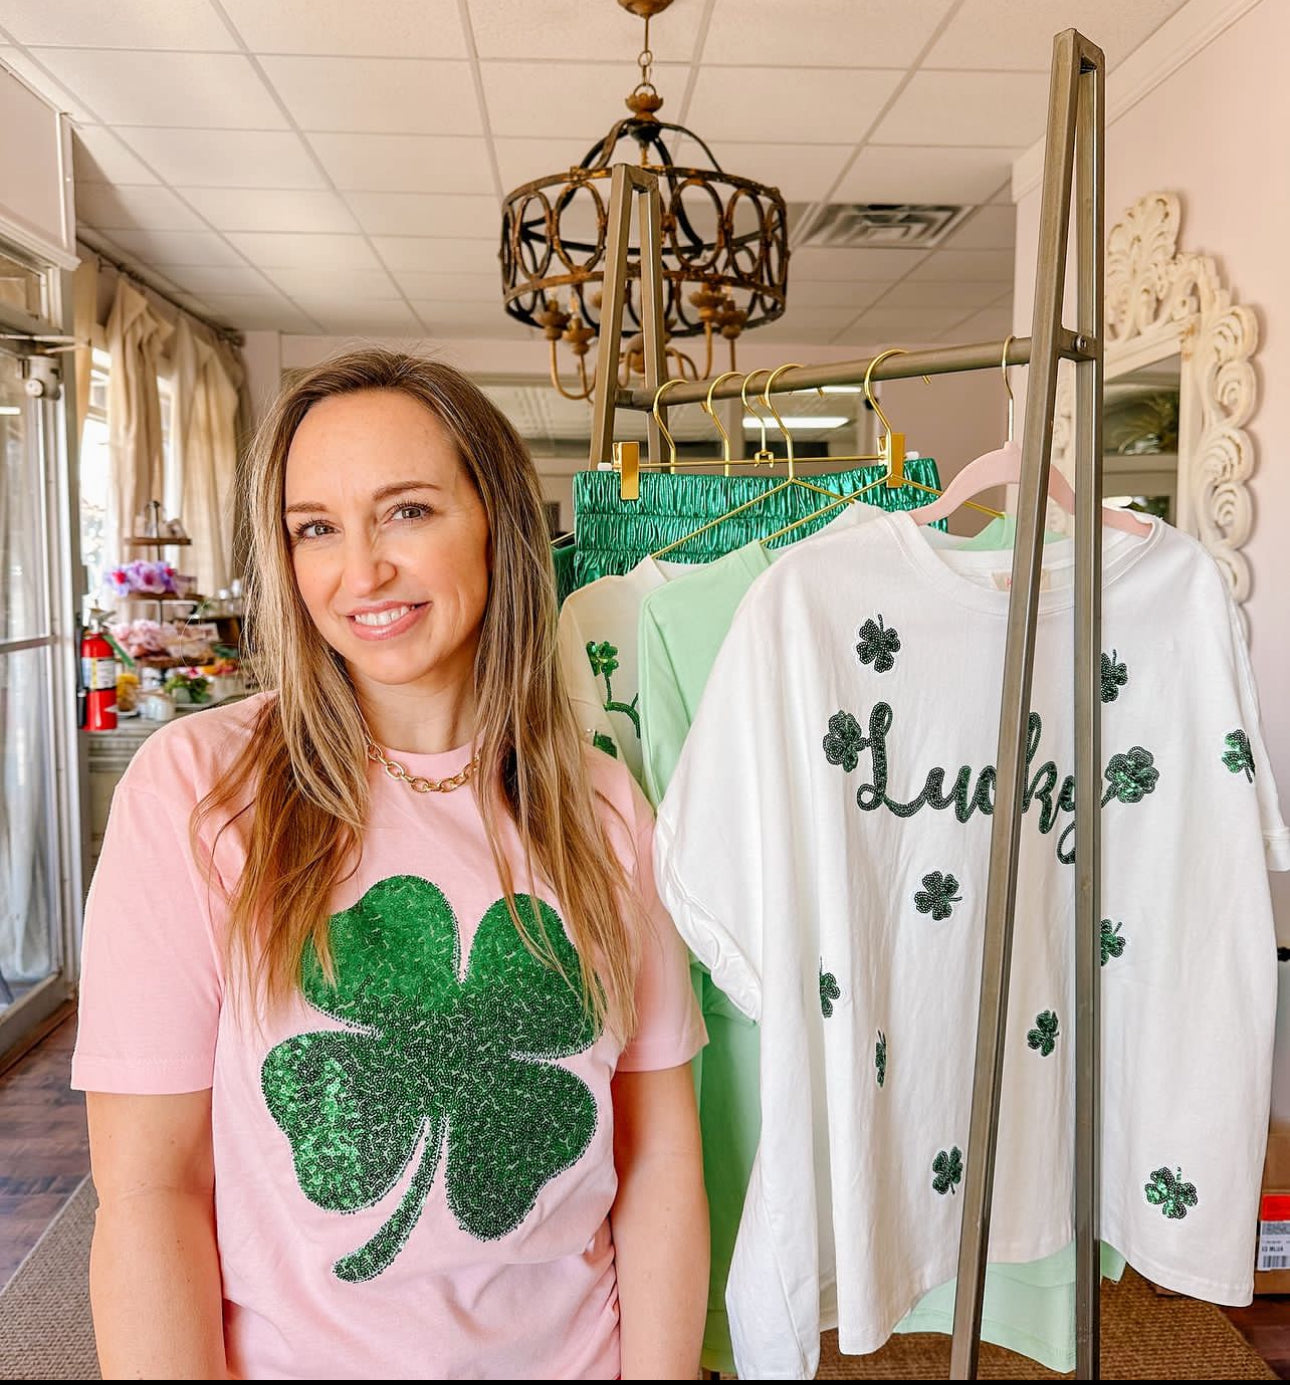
610;1064;708;1379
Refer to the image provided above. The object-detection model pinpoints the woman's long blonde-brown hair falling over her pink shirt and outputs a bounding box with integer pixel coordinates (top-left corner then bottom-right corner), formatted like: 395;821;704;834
193;348;637;1040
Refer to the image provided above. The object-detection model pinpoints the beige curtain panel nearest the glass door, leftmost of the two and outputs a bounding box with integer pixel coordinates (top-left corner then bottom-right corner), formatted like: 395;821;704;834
104;278;175;562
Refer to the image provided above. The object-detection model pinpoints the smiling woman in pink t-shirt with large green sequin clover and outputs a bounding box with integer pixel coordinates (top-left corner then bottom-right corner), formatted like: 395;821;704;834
73;349;708;1379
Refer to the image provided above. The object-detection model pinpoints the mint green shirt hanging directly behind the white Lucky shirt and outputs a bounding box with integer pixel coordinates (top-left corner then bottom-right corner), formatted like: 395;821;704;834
639;504;1124;1373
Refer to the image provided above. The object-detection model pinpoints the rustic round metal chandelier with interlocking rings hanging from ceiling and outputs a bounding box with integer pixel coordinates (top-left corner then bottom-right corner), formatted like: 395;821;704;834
502;0;788;399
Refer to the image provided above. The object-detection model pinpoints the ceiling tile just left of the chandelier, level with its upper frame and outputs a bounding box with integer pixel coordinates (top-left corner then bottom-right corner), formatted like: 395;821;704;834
309;134;493;193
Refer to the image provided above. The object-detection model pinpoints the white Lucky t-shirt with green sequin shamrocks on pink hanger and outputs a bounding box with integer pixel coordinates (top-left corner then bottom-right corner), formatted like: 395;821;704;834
655;514;1290;1378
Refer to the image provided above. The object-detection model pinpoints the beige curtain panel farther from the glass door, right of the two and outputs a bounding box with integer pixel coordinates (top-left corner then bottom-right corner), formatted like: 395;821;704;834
170;314;241;597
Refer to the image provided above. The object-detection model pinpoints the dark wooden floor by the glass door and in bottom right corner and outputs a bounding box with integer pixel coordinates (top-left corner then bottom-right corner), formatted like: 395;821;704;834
0;1019;1290;1379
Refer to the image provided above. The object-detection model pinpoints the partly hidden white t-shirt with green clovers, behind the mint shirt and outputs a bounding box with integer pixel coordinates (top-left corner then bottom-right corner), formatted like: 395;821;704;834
556;557;696;783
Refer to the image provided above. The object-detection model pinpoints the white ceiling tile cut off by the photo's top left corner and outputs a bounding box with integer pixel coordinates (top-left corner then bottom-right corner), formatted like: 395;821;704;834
0;0;236;53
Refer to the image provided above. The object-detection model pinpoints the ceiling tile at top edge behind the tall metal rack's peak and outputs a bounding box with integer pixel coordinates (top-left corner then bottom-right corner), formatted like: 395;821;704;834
924;0;1185;72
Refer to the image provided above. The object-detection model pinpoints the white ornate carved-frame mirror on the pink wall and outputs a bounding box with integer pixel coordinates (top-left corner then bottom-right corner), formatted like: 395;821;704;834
1053;193;1258;601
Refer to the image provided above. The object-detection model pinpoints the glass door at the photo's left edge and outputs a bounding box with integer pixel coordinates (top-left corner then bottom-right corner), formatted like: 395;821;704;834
0;343;80;1055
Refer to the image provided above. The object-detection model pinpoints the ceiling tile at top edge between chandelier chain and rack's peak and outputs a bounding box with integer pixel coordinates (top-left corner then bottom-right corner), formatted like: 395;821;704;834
701;0;953;68
